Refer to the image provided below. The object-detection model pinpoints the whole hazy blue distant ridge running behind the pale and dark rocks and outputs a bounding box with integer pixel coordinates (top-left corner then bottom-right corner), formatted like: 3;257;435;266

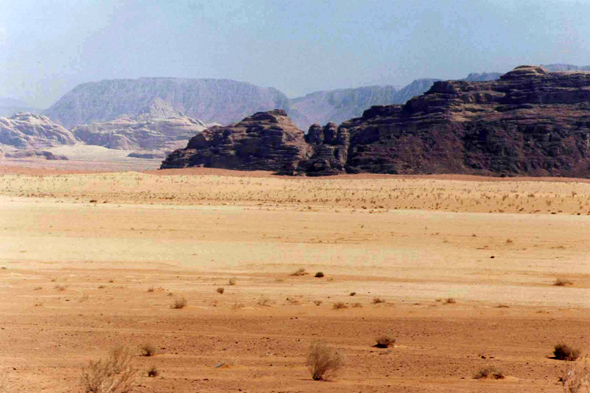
44;64;590;130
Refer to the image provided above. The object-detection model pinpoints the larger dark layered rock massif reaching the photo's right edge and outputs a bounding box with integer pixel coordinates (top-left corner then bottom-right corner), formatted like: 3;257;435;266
340;66;590;177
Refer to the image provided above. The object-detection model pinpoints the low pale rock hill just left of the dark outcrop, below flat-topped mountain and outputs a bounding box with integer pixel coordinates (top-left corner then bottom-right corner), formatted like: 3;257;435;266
72;113;212;150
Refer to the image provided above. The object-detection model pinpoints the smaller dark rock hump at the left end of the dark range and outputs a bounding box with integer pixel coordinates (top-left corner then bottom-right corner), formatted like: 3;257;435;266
157;109;311;171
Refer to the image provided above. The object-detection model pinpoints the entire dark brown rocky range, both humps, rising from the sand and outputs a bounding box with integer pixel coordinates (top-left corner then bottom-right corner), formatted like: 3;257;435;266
162;66;590;177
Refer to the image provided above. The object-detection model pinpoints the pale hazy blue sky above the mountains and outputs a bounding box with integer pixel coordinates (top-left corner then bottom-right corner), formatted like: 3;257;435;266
0;0;590;108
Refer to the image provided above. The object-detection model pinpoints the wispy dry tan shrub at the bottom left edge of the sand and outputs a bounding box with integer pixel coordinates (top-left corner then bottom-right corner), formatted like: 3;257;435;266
81;346;137;393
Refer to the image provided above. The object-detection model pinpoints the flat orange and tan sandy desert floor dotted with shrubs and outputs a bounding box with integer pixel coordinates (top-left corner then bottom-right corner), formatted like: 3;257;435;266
0;166;590;393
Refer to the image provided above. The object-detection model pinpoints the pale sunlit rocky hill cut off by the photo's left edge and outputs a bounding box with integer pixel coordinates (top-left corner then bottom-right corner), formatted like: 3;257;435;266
0;112;76;149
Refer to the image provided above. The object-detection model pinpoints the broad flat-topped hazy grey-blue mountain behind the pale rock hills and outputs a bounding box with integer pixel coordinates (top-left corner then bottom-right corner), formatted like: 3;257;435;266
44;78;289;128
